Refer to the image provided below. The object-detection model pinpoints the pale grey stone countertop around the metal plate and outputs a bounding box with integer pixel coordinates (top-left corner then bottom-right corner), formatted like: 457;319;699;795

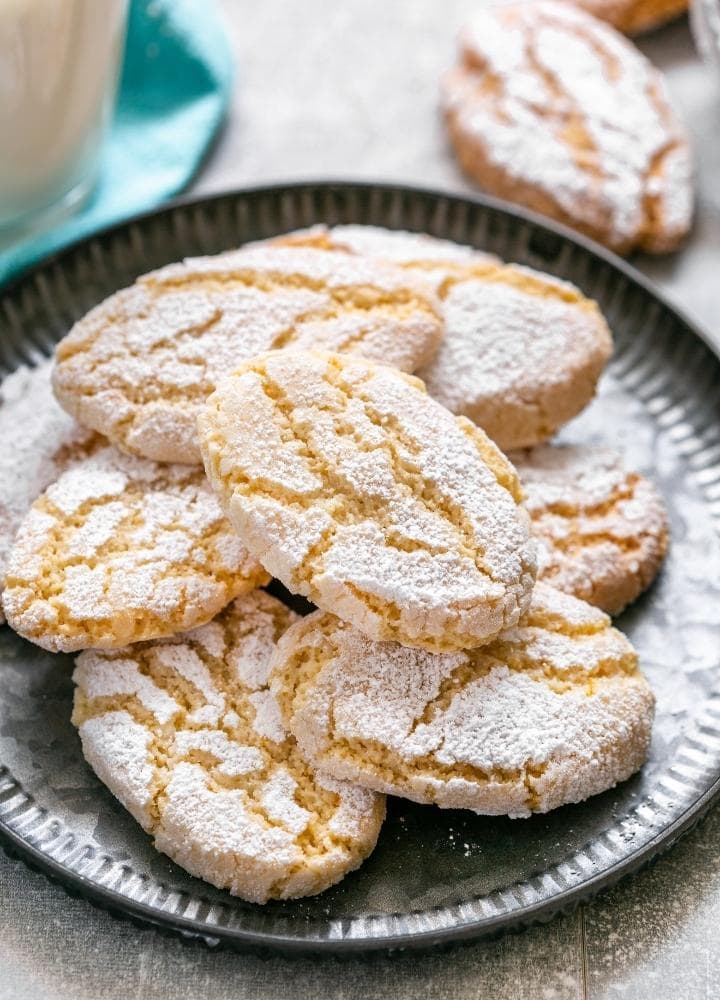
0;0;720;1000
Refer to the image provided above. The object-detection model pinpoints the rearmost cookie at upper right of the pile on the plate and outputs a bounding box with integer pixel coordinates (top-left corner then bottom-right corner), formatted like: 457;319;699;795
272;226;612;450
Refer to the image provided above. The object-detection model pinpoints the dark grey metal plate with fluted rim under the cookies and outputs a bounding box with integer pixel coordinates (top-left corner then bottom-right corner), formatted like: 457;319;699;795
0;184;720;953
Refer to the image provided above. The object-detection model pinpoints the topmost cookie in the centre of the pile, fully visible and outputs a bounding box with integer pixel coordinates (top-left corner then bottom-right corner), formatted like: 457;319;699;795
199;351;535;650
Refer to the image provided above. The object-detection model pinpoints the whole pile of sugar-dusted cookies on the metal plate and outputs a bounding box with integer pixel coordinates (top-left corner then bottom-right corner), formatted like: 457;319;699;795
0;232;667;902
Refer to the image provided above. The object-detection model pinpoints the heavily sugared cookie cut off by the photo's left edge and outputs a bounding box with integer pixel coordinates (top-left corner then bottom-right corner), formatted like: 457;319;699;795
0;361;102;623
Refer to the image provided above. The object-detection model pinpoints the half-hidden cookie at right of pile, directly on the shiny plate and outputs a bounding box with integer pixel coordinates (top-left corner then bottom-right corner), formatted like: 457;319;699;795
512;445;669;615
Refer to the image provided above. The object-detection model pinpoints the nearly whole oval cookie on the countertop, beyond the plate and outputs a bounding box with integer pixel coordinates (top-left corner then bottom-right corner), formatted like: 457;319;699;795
443;0;692;253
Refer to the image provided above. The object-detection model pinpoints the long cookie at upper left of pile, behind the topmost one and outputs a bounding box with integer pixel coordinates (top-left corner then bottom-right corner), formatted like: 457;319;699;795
54;246;442;464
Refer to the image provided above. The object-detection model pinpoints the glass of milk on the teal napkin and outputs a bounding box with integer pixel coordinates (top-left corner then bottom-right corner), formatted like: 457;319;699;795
0;0;128;235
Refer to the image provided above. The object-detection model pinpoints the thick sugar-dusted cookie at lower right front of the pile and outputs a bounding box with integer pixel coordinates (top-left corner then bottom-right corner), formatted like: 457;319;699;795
271;584;654;816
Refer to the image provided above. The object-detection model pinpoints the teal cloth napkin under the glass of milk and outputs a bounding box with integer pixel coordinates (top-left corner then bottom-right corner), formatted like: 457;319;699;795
0;0;232;282
